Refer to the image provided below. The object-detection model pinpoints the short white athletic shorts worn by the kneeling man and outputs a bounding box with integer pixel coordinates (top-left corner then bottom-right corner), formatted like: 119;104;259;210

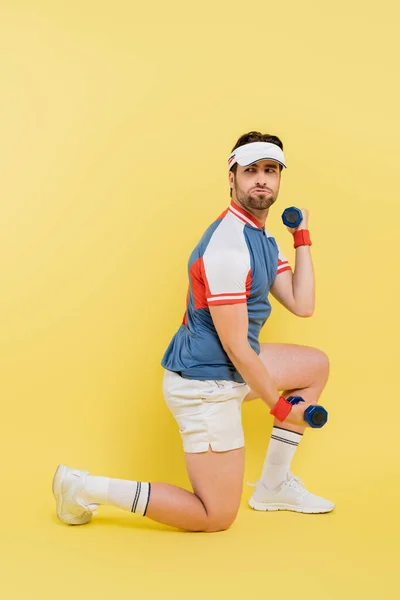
163;370;250;452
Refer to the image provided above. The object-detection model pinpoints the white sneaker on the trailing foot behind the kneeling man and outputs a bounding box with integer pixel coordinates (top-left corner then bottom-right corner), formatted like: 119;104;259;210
53;465;99;525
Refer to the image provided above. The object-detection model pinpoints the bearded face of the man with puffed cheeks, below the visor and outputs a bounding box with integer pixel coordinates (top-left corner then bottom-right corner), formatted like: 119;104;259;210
229;160;281;212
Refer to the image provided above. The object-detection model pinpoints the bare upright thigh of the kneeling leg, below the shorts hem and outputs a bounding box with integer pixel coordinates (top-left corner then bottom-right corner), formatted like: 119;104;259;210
185;448;245;531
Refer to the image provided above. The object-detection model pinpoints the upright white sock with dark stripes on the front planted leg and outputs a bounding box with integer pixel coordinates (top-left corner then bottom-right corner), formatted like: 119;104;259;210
261;427;303;490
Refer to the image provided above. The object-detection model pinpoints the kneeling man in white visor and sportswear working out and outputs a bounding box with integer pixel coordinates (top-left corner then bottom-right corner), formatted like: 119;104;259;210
53;131;334;532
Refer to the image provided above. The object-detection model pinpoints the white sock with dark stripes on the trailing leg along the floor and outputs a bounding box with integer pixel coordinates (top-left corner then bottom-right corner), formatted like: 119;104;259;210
79;475;151;516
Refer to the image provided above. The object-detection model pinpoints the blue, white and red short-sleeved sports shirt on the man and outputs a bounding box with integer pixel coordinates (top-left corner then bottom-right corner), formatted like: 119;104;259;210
161;201;291;383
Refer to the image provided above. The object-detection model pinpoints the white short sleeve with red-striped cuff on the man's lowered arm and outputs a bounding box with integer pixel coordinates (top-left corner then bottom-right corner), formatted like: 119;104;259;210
202;224;251;306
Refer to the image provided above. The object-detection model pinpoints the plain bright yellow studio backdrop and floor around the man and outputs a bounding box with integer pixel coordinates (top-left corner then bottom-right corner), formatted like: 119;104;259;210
0;0;400;600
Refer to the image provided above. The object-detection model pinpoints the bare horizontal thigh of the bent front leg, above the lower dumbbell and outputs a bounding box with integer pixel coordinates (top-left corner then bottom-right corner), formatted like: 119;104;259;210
245;344;329;401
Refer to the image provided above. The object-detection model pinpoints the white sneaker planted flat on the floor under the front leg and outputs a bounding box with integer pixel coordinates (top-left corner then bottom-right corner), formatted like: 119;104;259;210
249;471;335;513
